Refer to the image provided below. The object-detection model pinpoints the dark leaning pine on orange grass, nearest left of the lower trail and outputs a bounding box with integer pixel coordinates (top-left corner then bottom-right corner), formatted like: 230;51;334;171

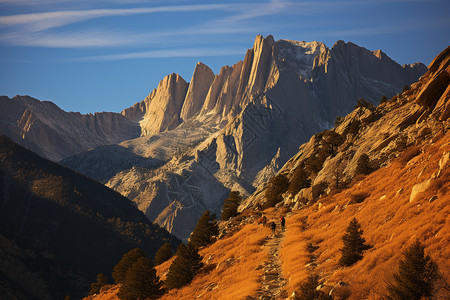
165;243;203;290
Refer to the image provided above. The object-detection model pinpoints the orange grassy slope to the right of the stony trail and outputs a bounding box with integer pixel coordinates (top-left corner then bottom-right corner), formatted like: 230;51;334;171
281;132;450;299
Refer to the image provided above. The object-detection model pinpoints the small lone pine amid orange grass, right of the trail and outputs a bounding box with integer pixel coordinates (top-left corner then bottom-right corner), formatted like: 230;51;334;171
339;218;372;266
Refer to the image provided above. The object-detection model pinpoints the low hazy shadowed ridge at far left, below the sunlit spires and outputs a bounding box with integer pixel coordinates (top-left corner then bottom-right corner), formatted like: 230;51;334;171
0;96;140;161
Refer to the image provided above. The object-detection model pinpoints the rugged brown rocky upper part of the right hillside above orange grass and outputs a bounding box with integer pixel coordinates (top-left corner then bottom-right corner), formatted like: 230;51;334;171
241;48;450;209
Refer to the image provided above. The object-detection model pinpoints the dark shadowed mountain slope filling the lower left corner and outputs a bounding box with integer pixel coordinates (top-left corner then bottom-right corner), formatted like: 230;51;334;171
0;136;178;299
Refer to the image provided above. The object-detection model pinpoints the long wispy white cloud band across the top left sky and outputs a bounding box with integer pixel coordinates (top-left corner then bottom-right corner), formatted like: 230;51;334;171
0;0;285;48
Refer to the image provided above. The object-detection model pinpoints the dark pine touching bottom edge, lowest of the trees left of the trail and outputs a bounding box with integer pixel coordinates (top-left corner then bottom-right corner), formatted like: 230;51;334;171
118;257;164;300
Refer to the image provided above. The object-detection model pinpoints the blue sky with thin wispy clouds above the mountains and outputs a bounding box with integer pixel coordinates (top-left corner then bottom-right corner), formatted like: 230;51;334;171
0;0;450;113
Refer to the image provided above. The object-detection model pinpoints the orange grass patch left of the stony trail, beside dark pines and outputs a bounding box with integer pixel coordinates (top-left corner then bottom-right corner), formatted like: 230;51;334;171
86;224;270;300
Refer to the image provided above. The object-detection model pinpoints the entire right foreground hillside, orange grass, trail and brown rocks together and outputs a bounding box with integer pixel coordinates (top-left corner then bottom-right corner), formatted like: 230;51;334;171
86;47;450;300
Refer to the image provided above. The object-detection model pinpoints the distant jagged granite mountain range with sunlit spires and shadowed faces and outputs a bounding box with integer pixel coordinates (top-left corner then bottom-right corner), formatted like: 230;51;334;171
0;36;427;240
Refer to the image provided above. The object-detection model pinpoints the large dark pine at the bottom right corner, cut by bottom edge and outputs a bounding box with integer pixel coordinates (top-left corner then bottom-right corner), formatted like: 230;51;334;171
387;241;438;300
